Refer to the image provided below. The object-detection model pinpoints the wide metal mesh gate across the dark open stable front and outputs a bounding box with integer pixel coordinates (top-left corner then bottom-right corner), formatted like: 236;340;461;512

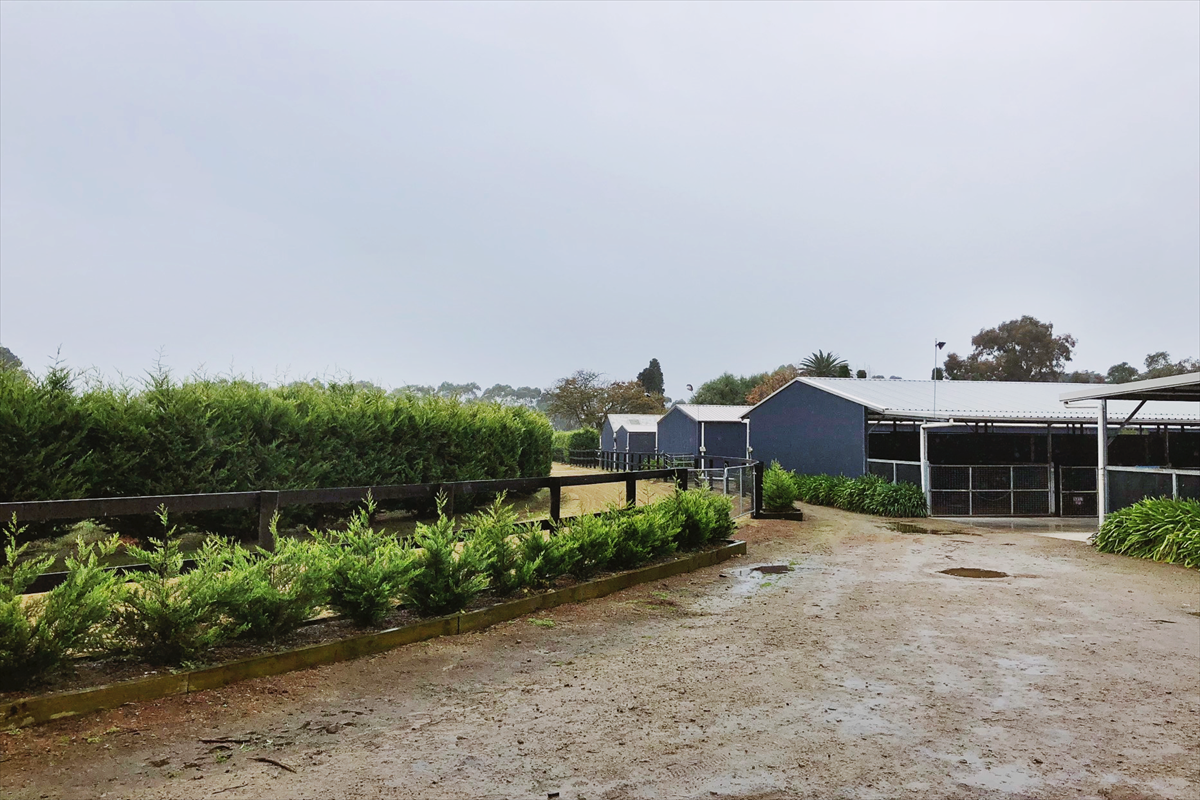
929;464;1054;517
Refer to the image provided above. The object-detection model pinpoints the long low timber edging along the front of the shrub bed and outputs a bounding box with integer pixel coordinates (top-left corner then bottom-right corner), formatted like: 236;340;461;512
0;541;746;728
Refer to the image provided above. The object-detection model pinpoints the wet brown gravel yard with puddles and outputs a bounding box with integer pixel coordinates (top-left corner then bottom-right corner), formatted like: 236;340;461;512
0;507;1200;800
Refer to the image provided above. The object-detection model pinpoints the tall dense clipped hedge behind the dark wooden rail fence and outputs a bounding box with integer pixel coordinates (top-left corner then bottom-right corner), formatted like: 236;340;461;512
0;368;552;537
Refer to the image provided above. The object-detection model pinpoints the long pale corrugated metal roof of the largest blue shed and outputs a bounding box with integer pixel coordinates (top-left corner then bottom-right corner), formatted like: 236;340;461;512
755;378;1200;425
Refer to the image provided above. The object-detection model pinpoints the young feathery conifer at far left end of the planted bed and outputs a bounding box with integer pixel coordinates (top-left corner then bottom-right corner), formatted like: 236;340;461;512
0;517;118;690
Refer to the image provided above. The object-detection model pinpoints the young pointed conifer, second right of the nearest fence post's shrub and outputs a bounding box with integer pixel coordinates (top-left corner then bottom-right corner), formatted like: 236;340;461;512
403;498;487;616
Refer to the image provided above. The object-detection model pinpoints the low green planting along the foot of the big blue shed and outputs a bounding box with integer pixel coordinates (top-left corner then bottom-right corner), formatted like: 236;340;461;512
762;462;929;517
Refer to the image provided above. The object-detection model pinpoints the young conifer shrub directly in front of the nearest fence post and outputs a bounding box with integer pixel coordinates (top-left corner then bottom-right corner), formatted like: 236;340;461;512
212;515;326;639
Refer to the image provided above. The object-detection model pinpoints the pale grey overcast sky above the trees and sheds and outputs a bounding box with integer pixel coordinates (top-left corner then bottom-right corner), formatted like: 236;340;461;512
0;0;1200;397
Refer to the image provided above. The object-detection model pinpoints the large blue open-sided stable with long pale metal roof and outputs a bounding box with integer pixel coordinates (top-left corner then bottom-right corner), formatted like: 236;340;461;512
743;375;1200;516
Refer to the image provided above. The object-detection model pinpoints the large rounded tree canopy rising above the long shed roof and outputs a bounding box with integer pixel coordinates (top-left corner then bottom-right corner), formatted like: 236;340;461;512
944;317;1075;381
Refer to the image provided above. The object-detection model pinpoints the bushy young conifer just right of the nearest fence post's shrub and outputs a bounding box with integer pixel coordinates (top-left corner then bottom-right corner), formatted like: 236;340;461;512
313;493;416;626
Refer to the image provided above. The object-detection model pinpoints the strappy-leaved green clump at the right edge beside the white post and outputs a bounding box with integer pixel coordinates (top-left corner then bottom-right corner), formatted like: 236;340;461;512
1092;498;1200;567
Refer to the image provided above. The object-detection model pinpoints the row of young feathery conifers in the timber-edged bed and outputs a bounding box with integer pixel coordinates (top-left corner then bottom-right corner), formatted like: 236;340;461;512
0;489;733;690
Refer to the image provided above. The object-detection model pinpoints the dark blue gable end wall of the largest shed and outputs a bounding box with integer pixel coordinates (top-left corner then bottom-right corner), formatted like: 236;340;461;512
750;383;866;477
